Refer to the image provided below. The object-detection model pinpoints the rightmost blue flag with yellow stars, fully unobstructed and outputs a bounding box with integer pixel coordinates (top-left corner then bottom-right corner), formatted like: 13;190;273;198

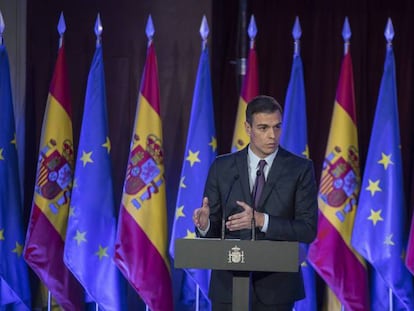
352;44;414;310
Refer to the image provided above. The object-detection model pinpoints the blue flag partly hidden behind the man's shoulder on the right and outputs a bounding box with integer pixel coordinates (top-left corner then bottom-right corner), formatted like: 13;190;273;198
280;50;317;311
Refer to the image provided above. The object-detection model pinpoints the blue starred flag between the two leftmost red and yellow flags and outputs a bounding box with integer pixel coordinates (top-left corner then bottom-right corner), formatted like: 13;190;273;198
64;45;123;311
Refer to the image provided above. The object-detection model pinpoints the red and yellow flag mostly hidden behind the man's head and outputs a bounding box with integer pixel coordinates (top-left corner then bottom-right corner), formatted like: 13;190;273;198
231;41;259;152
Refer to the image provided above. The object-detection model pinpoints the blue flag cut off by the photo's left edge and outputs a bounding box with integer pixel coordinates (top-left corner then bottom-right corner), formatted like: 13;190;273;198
0;43;30;310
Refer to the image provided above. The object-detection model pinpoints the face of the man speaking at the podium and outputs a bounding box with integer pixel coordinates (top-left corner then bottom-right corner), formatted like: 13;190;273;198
244;111;282;158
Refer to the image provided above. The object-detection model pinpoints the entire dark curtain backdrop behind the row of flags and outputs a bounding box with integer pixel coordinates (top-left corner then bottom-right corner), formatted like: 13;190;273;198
25;0;414;310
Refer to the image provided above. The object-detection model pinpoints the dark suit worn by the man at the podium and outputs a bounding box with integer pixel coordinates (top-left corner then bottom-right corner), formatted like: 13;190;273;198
205;147;318;304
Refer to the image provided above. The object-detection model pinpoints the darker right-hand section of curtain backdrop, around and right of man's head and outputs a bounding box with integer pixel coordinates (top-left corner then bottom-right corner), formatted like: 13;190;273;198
213;0;414;202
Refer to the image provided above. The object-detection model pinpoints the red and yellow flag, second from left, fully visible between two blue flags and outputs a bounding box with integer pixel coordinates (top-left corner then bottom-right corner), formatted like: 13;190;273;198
115;42;173;311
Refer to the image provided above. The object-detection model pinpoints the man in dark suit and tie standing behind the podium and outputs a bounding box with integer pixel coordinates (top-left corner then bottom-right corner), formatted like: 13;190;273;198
193;95;318;311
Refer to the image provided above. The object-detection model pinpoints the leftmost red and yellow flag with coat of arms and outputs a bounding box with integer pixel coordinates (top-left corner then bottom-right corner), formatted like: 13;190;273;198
24;45;82;310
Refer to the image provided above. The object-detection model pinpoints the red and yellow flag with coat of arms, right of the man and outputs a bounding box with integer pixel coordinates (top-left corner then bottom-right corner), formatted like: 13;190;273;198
308;52;369;311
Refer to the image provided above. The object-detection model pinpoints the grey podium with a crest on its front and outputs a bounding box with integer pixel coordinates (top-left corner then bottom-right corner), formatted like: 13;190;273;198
174;238;299;311
